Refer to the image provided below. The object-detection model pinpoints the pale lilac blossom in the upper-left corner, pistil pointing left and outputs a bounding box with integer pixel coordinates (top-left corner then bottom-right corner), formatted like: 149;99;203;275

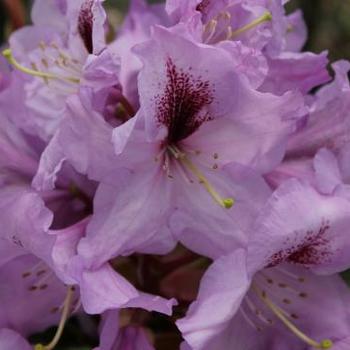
2;0;119;141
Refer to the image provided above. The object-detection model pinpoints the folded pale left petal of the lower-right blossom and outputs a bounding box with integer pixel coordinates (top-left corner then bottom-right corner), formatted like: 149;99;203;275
176;250;250;350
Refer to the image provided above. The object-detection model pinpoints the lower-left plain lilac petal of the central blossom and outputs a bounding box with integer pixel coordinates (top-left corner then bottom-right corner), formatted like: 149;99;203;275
78;165;174;267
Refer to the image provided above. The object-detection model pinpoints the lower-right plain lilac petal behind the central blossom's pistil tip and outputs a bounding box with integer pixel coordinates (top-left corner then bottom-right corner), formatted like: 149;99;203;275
170;164;270;258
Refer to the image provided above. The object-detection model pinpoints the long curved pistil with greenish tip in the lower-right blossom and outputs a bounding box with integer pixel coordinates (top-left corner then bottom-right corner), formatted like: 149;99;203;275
252;285;333;349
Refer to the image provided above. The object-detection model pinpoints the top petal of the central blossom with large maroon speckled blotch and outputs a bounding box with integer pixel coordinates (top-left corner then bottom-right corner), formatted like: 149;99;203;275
133;27;243;139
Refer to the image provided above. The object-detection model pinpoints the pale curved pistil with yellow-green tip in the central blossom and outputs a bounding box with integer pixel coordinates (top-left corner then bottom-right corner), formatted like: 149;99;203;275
168;146;234;209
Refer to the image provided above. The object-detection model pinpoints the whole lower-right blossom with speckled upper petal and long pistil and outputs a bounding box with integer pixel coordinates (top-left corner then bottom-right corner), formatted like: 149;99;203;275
177;180;350;349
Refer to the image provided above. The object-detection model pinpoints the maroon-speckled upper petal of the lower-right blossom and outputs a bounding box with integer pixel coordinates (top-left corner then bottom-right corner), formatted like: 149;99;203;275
248;180;350;274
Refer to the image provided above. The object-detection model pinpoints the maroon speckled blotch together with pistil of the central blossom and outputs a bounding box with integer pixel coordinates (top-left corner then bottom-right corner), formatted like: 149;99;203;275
156;57;234;209
